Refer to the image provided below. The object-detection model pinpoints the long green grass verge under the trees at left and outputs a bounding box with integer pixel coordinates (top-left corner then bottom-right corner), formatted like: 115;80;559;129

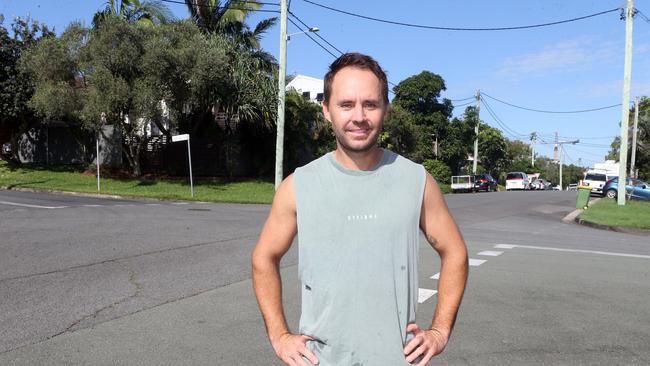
0;161;275;203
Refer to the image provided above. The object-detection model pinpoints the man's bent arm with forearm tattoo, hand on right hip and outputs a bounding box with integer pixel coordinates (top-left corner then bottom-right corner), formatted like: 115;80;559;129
404;174;468;365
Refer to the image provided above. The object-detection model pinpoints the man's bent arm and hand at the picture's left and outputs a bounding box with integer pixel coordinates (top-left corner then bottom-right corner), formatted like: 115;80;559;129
251;175;318;366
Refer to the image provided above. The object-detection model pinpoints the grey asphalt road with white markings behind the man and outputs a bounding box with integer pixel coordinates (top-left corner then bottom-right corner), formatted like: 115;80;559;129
0;191;650;365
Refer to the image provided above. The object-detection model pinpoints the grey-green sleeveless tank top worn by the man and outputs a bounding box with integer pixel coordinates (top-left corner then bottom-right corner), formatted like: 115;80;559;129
294;150;426;366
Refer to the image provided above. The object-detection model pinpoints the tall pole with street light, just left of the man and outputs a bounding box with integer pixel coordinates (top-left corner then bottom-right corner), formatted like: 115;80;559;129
275;0;287;190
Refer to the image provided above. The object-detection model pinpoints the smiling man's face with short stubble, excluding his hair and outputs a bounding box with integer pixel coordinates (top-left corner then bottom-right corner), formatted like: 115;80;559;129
323;67;388;153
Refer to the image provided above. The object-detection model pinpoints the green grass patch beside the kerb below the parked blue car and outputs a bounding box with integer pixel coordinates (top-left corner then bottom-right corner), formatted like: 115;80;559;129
580;198;650;229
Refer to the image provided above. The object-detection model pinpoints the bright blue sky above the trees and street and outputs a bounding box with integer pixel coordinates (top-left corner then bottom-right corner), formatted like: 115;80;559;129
0;0;650;166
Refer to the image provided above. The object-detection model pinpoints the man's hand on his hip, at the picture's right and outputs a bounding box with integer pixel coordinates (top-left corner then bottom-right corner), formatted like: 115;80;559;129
404;323;448;366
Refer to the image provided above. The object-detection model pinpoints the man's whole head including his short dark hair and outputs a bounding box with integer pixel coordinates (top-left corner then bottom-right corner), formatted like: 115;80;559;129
323;53;388;154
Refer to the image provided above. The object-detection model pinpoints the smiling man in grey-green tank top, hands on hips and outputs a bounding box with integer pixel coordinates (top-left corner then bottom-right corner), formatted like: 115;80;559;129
252;53;467;366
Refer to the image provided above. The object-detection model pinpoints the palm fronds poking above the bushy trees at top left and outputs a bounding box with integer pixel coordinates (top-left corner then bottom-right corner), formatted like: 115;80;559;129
93;0;174;28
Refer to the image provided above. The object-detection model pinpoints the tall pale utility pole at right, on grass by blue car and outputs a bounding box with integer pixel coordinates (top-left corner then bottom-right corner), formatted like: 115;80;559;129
617;0;634;206
